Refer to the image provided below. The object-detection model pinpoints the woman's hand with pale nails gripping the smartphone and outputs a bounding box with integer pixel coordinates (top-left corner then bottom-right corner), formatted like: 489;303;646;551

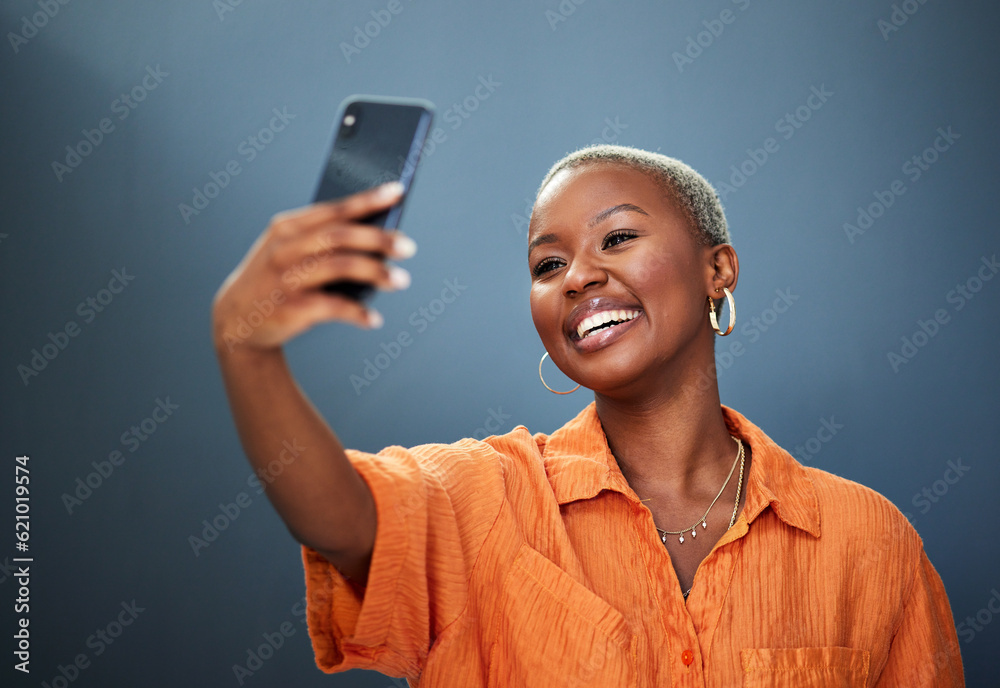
212;182;416;353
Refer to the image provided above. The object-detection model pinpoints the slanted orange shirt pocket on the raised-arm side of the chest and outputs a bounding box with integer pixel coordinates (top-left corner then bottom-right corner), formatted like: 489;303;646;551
487;545;636;688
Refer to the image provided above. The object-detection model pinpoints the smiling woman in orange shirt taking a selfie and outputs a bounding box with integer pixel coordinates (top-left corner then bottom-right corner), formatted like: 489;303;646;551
214;146;963;688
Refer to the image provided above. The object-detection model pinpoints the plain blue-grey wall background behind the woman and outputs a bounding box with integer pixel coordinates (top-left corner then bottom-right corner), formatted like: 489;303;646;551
0;0;1000;687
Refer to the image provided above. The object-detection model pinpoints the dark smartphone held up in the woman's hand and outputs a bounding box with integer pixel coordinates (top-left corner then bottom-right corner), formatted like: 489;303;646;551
313;95;434;301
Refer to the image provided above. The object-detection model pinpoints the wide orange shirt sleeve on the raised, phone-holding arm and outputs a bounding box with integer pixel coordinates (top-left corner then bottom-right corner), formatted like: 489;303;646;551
302;440;503;677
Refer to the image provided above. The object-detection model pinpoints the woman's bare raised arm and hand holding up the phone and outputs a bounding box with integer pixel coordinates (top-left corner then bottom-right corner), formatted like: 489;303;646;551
212;180;413;584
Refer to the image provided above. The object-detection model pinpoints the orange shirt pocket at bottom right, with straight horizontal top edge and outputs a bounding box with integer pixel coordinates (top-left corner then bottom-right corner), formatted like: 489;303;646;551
740;647;869;688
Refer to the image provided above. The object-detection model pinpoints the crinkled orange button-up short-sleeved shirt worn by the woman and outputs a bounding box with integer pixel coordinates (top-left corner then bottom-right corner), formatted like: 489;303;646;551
303;402;964;688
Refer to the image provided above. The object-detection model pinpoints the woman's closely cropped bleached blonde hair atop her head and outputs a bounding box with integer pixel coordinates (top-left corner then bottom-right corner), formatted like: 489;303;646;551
535;144;730;246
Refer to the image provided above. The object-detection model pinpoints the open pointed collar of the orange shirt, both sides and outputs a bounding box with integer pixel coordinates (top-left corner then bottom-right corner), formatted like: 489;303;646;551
543;401;820;537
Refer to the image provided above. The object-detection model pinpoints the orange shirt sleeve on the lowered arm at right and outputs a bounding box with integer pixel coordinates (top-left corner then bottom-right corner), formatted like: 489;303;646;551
875;547;965;688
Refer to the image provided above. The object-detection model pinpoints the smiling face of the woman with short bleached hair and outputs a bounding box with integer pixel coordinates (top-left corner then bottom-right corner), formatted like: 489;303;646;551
528;163;719;393
